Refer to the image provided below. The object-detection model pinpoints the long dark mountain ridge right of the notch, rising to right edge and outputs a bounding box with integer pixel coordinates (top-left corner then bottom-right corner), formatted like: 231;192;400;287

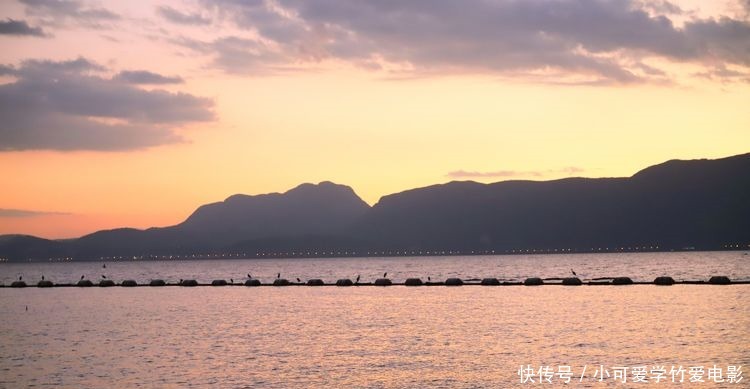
355;154;750;250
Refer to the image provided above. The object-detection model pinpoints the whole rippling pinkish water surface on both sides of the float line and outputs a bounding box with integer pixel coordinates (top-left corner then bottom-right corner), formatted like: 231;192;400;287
0;253;750;388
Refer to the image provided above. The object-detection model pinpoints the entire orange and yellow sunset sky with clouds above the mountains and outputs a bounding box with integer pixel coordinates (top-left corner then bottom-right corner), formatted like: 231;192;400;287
0;0;750;238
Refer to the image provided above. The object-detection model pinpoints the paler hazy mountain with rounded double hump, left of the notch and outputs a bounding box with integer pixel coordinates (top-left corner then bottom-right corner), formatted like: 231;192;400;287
63;181;370;257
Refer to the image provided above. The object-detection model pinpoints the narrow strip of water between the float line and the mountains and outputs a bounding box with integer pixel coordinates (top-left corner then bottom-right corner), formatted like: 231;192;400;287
0;251;750;285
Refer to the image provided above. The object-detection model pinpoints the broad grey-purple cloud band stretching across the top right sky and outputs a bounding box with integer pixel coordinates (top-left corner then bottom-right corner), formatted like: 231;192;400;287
179;0;750;83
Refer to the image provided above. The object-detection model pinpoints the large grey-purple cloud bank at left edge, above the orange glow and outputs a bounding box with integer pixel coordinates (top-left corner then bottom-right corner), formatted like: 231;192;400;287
0;58;214;151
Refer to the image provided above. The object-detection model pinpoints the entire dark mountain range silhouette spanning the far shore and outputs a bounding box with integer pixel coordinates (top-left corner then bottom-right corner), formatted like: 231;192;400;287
0;154;750;260
